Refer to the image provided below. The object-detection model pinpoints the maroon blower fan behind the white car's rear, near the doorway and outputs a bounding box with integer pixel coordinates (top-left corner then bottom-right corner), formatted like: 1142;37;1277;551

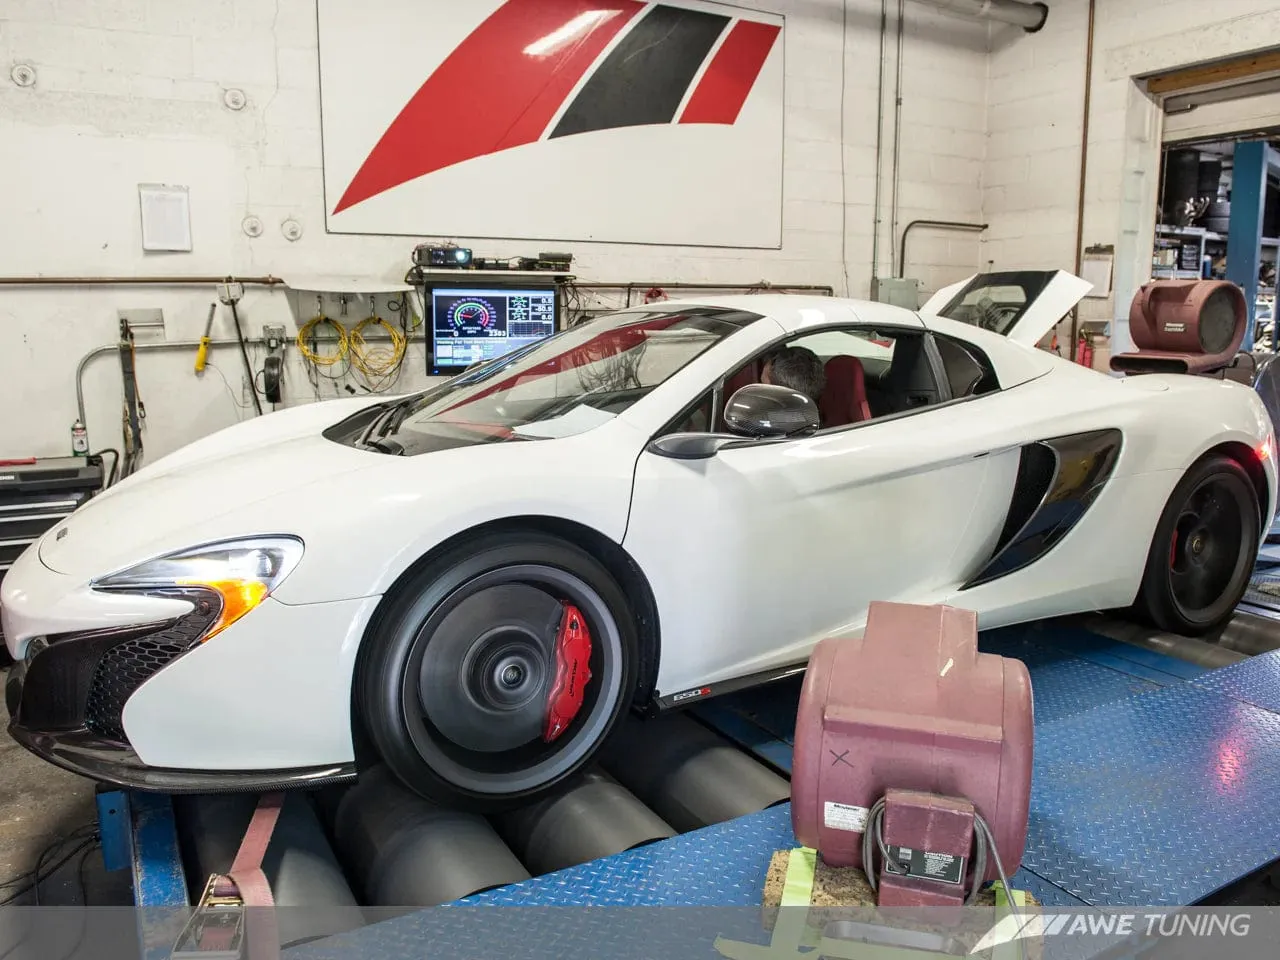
1111;280;1249;374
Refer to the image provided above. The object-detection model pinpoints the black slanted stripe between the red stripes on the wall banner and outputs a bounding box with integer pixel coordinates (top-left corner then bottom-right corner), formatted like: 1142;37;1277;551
552;6;730;137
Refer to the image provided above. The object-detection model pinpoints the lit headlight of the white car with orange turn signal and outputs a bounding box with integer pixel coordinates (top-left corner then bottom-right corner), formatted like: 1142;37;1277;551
90;536;302;640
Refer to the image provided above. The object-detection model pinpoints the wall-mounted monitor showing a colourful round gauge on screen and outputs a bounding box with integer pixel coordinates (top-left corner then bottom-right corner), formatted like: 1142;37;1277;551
430;284;558;375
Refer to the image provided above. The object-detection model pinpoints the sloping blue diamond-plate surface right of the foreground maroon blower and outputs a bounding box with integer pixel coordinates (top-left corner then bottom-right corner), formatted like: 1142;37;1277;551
1023;684;1280;906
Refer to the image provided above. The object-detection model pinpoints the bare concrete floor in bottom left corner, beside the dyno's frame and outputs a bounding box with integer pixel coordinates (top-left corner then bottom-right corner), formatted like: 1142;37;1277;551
0;669;131;904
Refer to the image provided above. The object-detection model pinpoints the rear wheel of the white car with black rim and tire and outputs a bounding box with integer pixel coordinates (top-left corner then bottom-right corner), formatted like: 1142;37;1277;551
1135;456;1262;636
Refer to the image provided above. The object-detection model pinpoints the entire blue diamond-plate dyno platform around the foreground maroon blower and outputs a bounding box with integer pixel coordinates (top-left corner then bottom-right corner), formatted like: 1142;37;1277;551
450;623;1280;906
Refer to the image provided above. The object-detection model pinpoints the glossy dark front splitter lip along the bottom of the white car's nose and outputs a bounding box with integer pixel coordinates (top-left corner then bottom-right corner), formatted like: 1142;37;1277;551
5;649;356;794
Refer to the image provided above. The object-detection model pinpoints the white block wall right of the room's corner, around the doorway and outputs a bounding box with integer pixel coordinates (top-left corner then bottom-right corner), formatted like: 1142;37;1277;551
983;0;1280;349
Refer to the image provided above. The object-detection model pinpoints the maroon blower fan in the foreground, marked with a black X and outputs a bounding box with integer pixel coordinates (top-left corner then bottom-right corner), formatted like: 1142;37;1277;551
791;602;1033;906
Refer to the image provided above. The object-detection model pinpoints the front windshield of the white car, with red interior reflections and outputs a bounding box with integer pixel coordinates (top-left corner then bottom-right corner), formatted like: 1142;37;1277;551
363;307;760;454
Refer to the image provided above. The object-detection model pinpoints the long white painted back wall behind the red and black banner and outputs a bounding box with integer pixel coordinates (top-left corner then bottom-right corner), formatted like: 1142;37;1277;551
0;0;987;458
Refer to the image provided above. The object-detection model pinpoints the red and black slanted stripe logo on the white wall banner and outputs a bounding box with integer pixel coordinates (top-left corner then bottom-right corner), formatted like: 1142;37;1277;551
333;0;781;214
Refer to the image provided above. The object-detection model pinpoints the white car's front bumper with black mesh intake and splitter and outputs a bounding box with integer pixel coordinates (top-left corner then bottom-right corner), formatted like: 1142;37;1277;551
0;542;379;792
